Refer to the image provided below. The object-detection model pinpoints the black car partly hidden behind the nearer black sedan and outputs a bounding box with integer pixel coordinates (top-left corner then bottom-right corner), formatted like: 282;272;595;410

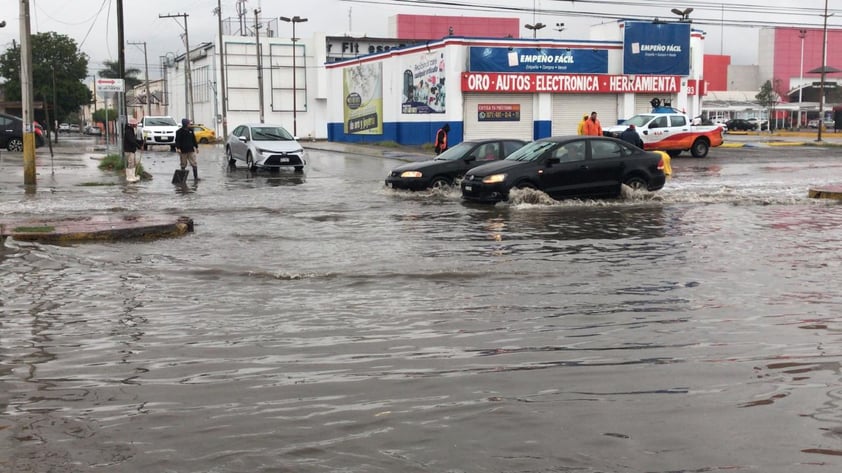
386;139;526;190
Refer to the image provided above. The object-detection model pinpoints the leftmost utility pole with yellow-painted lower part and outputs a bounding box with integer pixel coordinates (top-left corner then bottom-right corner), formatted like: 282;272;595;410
20;0;35;186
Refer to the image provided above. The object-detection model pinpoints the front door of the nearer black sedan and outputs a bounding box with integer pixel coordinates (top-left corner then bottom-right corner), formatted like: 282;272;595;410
538;139;590;198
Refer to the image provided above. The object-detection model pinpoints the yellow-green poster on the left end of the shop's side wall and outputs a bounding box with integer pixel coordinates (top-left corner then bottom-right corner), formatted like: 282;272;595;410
342;63;383;135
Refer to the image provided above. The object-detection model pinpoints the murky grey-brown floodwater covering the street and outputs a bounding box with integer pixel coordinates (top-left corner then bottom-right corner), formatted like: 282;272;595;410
0;141;842;473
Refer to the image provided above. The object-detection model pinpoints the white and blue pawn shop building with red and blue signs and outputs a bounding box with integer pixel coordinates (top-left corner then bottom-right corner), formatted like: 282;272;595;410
325;22;704;144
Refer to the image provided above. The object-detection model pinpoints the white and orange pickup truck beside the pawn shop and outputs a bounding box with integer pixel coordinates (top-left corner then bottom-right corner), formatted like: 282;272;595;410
603;107;723;158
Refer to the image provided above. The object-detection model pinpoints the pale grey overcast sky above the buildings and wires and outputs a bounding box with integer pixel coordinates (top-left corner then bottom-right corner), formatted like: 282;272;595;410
0;0;842;77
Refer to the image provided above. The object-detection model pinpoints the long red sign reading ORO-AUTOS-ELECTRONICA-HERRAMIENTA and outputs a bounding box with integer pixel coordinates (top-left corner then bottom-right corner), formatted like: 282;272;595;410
462;72;681;94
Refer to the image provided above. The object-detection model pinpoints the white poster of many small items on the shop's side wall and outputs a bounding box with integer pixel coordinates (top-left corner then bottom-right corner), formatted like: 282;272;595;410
401;52;447;114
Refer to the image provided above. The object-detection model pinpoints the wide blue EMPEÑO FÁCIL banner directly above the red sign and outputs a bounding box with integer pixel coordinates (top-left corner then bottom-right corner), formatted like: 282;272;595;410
468;47;608;74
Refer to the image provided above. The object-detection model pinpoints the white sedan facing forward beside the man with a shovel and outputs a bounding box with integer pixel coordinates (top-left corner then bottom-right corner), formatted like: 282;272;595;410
225;123;307;172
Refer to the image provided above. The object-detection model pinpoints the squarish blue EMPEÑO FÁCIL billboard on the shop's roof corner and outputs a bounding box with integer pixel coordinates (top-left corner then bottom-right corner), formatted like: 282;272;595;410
623;21;690;76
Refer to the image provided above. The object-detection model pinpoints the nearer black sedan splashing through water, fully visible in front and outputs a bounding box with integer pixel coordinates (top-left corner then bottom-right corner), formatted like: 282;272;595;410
462;135;666;203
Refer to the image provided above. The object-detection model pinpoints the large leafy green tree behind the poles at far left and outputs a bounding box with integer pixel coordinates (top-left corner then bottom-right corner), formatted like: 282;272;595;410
0;31;91;121
